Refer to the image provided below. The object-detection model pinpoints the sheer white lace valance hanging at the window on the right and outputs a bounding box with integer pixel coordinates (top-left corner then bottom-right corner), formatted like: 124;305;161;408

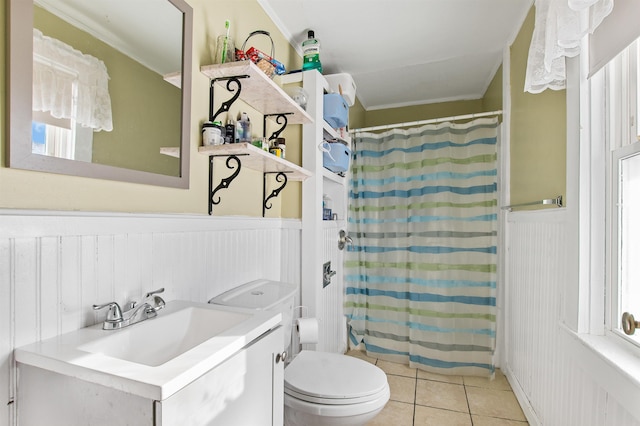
524;0;613;93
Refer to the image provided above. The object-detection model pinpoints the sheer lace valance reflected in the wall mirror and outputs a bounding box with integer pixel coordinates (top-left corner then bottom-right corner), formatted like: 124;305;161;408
33;29;113;131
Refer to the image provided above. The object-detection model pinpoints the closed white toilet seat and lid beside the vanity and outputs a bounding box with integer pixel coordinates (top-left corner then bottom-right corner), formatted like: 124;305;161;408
284;351;389;405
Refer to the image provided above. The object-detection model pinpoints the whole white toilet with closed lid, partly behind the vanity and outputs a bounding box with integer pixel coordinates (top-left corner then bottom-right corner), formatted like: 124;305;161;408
209;280;390;426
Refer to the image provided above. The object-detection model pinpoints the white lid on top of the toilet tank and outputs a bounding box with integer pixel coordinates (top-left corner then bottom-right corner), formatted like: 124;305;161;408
209;279;298;309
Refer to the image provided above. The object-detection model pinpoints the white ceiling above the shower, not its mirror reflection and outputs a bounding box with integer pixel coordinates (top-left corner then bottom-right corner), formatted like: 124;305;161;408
258;0;533;110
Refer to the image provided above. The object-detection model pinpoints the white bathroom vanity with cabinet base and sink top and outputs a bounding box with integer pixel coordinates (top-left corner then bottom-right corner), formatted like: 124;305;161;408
15;301;284;426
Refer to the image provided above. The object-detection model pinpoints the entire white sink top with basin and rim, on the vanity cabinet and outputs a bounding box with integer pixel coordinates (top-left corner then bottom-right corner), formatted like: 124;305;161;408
15;301;281;401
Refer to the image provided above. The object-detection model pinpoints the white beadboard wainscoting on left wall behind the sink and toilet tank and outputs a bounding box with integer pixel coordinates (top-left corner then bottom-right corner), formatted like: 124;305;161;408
0;210;301;426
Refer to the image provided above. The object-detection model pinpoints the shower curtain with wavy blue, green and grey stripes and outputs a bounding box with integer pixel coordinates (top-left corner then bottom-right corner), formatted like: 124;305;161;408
345;118;498;376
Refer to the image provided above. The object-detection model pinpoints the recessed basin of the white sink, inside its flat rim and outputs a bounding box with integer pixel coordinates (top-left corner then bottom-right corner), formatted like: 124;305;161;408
78;307;251;367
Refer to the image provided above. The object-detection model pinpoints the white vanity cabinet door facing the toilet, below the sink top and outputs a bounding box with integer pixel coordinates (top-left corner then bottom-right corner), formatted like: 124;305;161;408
155;327;284;426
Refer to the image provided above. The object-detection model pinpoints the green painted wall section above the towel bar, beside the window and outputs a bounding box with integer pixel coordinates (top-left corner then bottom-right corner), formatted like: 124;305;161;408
510;8;567;208
